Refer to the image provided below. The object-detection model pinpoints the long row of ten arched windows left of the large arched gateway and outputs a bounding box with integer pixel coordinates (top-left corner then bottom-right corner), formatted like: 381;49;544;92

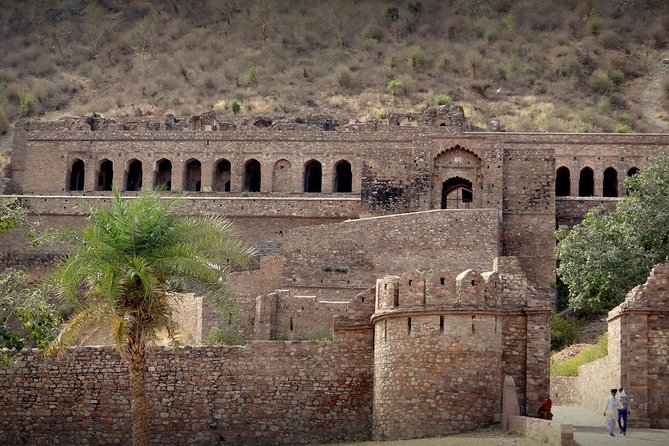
67;158;353;192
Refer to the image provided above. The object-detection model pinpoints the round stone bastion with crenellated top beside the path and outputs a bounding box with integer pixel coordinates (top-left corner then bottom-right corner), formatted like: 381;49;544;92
372;257;548;440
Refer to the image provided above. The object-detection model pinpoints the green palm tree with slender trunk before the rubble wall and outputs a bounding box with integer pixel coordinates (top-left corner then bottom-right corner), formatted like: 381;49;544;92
45;190;254;446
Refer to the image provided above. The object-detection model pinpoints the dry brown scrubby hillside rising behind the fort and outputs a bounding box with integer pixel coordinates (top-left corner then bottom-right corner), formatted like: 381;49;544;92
0;0;669;145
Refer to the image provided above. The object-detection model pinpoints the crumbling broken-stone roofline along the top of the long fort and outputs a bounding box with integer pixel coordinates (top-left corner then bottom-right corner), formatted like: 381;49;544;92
17;105;464;133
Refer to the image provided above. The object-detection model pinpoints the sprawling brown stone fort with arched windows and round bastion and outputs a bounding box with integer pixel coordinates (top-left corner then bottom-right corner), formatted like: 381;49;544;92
0;107;669;445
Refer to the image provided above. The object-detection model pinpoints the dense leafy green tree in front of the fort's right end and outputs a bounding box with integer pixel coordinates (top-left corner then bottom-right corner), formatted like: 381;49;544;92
556;156;669;312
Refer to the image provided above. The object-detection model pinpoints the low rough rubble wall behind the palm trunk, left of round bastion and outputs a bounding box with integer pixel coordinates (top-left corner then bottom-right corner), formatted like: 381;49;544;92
0;326;373;445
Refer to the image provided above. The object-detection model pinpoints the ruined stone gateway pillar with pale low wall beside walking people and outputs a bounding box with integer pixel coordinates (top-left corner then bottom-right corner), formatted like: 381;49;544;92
551;264;669;429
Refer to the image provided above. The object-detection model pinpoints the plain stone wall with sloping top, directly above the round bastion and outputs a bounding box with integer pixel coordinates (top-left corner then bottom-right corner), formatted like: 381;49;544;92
277;209;499;300
